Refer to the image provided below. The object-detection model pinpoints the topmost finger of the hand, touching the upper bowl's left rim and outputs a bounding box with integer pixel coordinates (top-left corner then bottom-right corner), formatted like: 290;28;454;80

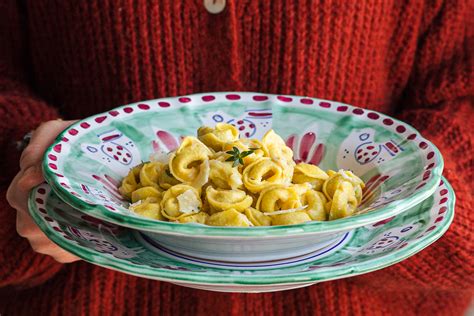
20;120;76;169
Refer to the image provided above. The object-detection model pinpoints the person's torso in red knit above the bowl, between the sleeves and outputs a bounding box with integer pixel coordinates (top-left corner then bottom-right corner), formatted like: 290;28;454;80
26;0;423;118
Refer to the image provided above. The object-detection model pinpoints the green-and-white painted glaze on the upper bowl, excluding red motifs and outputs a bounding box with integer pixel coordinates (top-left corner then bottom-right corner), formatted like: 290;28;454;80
43;93;443;236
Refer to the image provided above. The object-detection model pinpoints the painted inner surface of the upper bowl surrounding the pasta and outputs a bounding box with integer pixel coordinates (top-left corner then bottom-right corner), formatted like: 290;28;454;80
44;93;443;235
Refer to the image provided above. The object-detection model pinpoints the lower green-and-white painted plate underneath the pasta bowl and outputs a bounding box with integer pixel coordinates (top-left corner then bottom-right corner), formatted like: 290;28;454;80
29;179;455;292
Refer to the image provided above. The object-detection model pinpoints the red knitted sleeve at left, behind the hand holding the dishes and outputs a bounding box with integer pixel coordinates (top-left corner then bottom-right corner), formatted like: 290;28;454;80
0;0;61;287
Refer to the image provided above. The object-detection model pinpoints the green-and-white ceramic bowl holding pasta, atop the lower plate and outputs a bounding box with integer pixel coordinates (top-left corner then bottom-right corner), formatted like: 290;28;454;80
43;92;443;262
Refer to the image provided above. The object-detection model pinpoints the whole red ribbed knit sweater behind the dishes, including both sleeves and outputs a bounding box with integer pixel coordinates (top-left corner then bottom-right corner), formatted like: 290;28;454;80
0;0;474;315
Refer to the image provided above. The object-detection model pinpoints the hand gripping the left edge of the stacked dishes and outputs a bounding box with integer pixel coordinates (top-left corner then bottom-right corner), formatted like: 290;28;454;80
7;120;79;263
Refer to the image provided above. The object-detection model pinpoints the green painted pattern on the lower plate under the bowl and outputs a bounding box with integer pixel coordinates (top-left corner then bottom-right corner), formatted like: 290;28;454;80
29;179;455;285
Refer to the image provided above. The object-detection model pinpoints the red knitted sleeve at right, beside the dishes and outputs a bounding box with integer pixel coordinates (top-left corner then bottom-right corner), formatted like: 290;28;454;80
358;1;474;291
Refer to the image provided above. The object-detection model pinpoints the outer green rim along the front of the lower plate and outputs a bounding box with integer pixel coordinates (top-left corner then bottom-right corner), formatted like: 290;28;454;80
28;177;456;285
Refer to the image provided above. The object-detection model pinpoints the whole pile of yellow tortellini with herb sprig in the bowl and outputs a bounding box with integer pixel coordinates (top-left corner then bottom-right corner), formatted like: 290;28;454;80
119;123;364;227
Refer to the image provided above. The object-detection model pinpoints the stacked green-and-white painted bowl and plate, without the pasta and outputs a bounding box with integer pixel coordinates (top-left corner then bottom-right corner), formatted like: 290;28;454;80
29;92;455;292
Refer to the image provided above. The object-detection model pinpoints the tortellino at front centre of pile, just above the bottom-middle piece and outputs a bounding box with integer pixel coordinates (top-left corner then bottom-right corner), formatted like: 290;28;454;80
206;186;253;213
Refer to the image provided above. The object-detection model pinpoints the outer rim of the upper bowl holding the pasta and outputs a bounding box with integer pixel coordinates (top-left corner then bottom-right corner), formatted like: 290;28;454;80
42;91;444;238
